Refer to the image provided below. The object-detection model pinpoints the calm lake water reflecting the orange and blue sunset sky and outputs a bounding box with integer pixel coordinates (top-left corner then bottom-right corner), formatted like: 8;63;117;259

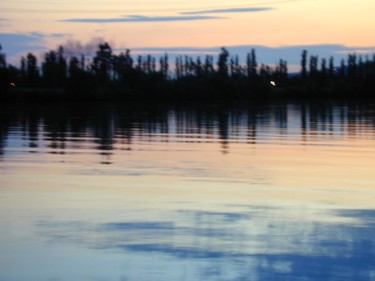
0;101;375;281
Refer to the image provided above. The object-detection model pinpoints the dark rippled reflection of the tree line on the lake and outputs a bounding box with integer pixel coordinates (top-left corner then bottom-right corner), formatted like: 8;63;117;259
0;102;375;159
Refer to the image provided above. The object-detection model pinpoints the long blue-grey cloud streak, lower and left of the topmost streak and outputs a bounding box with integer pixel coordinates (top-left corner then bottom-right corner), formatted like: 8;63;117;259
62;15;222;23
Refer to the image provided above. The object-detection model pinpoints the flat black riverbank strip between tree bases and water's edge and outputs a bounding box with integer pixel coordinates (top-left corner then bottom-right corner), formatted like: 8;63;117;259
0;84;375;103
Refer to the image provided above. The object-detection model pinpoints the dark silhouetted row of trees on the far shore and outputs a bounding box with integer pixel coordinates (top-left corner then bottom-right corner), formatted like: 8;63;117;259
0;43;375;100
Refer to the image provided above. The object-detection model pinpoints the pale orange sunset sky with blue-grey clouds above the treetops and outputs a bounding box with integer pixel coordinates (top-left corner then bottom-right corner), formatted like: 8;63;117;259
0;0;375;69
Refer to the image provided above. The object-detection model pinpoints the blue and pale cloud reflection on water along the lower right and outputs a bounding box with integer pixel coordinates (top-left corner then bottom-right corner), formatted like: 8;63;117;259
38;206;375;280
